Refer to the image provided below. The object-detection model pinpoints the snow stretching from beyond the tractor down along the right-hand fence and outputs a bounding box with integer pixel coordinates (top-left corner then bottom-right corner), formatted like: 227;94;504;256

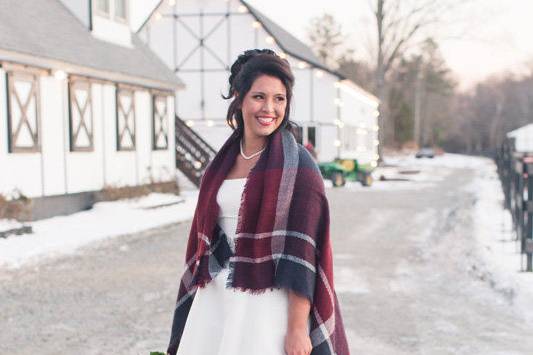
383;154;533;310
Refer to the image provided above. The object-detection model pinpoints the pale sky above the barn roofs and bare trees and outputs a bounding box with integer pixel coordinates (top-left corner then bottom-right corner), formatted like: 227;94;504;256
132;0;533;92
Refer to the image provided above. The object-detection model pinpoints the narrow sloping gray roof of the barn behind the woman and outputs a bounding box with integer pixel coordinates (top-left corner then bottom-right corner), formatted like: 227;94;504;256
241;0;342;77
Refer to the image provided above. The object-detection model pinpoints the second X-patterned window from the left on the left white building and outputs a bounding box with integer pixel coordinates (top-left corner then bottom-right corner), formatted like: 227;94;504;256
68;79;94;152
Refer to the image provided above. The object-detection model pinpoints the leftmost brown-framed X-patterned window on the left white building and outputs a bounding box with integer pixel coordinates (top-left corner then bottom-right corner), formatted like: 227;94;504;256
6;72;41;153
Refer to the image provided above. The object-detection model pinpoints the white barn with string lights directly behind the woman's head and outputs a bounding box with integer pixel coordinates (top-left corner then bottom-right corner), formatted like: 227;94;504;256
138;0;379;166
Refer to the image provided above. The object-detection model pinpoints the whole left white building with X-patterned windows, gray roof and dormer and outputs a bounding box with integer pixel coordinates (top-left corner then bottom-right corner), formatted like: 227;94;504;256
0;0;183;218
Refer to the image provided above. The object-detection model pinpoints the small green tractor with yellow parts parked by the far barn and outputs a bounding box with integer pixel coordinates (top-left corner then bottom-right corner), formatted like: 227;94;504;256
318;159;373;187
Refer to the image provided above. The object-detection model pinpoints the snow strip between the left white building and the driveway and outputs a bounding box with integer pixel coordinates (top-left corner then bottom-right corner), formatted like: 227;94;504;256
0;191;198;268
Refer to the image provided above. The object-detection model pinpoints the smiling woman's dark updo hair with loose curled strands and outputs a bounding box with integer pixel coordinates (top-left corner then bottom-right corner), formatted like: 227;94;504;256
222;49;296;136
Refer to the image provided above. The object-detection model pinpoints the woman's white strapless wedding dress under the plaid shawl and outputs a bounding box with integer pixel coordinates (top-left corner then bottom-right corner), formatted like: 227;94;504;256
177;179;288;355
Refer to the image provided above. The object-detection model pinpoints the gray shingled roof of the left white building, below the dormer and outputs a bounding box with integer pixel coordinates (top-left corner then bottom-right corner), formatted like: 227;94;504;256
0;0;183;87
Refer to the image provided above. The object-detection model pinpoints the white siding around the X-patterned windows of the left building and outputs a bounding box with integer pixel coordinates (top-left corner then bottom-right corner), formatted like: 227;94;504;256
0;70;179;197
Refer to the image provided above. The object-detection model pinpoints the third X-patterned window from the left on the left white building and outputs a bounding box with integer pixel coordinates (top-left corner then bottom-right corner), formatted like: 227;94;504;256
116;87;135;150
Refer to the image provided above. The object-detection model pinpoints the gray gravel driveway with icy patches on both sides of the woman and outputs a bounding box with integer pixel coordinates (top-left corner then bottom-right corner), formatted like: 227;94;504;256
0;162;533;355
